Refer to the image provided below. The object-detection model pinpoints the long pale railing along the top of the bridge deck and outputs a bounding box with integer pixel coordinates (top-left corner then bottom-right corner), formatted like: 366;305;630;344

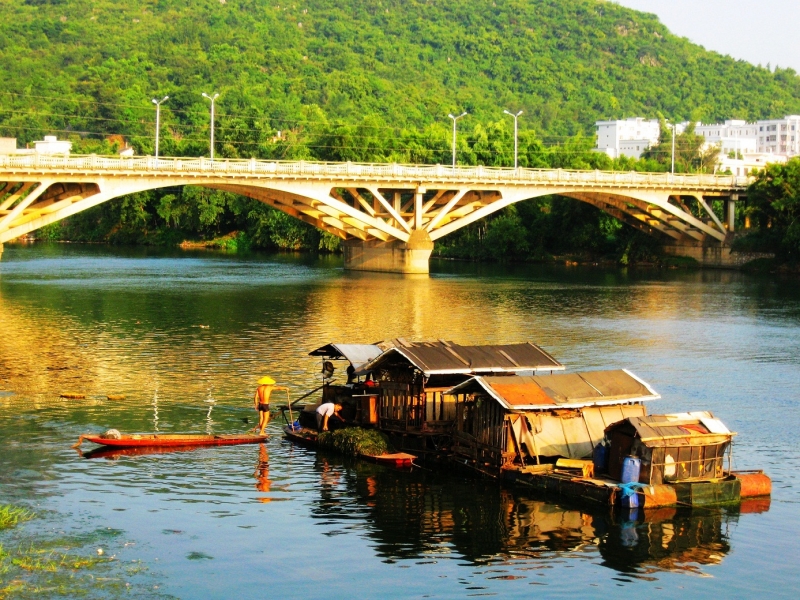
0;153;751;189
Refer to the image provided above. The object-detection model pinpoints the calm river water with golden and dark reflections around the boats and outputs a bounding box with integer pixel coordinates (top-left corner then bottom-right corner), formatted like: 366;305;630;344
0;245;800;598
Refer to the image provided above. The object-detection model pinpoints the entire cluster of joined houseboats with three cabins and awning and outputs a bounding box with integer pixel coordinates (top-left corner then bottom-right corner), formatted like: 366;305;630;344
286;339;771;507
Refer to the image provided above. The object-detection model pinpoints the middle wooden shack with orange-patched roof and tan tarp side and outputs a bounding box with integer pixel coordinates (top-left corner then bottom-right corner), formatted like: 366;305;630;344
446;369;660;476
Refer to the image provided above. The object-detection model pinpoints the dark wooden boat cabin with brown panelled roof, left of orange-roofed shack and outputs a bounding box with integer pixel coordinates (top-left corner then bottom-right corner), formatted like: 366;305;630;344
356;339;564;436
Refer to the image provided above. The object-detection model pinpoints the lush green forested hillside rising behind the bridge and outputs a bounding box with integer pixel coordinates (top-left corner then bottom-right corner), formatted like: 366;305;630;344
0;0;800;262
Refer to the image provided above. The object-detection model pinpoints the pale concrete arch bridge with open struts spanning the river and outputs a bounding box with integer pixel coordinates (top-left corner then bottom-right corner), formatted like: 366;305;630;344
0;154;749;273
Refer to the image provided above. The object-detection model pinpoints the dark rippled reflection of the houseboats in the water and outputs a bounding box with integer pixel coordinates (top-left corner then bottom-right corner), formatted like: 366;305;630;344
313;455;769;578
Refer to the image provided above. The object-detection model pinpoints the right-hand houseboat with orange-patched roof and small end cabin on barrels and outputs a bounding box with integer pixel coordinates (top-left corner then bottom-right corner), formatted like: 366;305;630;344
445;376;771;508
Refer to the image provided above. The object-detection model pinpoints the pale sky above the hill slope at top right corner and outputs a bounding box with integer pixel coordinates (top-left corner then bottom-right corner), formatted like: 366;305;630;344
616;0;800;72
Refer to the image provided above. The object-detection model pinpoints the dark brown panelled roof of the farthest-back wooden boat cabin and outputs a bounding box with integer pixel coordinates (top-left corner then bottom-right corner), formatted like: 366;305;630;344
361;339;564;376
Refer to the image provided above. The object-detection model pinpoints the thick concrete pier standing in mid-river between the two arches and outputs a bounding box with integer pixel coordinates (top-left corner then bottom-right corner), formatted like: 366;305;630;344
343;230;433;273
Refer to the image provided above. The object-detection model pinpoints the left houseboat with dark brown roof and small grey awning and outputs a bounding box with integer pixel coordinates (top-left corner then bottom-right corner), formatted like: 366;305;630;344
299;339;564;459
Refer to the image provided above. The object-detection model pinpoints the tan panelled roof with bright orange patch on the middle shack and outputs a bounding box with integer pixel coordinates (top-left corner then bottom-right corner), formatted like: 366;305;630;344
445;369;661;410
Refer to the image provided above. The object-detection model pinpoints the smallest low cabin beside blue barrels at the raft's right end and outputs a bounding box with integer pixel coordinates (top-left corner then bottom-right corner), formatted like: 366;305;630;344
606;412;736;485
